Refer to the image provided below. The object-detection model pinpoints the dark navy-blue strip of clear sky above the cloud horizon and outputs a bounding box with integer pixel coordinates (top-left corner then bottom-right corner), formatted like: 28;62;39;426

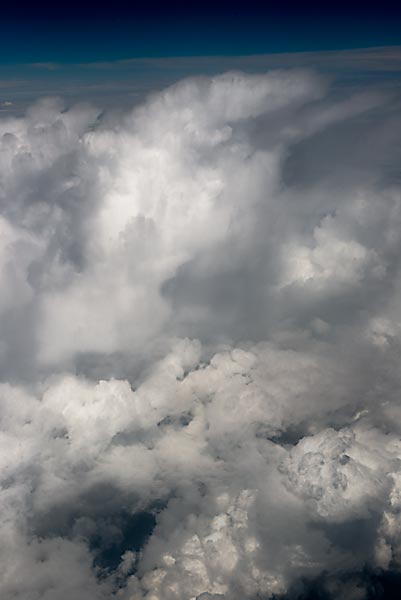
0;0;401;64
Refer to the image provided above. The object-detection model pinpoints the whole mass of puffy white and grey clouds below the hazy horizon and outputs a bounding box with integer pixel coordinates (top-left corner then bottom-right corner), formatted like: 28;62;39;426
0;71;401;600
